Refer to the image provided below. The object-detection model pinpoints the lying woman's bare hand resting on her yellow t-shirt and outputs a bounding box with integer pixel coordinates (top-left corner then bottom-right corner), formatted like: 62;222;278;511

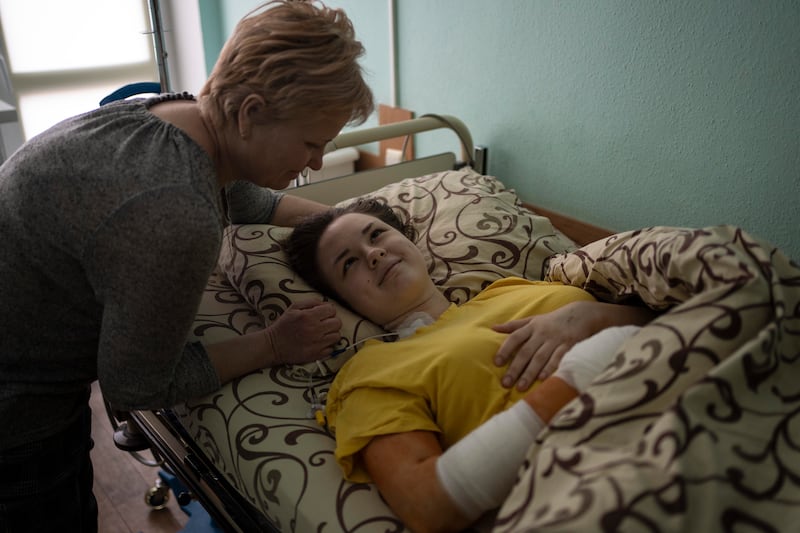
492;302;599;390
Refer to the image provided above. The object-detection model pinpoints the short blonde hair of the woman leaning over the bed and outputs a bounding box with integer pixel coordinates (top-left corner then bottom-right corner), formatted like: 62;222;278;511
198;0;374;127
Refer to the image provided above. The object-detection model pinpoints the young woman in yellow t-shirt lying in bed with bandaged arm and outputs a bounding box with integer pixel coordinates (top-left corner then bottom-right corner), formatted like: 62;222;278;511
285;200;653;531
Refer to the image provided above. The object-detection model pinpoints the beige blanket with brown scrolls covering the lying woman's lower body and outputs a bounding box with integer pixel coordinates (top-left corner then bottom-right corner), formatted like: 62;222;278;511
495;226;800;532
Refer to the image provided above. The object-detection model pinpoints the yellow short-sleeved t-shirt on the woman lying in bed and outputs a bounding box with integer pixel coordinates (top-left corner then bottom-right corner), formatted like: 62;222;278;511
326;278;594;482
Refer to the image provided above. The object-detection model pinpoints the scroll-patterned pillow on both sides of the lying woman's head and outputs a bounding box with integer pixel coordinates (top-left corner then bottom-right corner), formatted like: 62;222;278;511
219;168;577;374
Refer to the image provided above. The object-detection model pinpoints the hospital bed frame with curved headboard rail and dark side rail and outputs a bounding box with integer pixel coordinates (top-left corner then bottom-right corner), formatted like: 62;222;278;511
117;115;611;532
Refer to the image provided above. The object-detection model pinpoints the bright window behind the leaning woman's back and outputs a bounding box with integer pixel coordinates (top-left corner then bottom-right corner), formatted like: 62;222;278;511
0;0;158;139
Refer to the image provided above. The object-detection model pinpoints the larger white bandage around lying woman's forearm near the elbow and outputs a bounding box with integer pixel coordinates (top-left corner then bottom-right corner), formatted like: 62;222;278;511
436;400;544;521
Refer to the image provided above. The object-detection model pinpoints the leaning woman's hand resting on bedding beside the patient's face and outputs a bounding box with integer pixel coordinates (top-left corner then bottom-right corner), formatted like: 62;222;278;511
266;301;342;364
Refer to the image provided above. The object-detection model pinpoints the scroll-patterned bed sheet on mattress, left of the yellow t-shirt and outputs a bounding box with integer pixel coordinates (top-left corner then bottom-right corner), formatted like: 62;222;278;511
173;271;405;533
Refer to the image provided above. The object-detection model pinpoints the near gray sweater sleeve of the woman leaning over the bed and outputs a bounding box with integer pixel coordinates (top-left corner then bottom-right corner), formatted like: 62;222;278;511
85;185;220;410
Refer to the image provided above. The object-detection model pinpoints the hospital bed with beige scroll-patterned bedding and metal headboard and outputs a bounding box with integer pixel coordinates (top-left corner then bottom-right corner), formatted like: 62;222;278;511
119;116;800;532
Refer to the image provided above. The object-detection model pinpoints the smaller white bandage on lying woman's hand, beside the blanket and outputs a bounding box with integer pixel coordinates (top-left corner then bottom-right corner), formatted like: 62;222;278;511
553;326;641;392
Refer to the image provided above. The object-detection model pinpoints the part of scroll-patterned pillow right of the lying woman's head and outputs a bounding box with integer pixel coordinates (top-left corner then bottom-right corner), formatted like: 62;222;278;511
360;169;577;304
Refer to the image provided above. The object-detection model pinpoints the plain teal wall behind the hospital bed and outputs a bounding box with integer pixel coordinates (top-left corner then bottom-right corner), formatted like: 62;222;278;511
202;0;800;260
